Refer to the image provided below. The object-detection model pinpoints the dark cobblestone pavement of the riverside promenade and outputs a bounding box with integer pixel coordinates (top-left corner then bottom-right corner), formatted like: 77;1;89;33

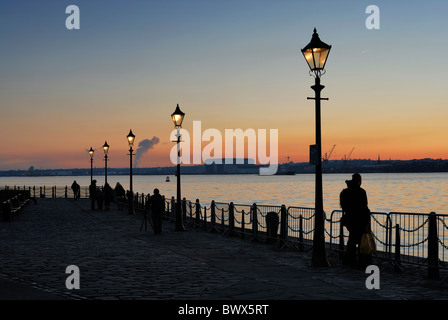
0;199;448;301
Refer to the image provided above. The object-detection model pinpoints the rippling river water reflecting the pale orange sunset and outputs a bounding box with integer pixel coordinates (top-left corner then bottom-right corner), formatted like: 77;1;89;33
0;173;448;214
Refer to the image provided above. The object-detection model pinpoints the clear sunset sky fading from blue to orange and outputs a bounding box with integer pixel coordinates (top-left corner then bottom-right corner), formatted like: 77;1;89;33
0;0;448;170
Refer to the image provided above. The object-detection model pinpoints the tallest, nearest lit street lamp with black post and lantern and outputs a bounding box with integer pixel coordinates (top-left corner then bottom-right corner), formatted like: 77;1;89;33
302;28;331;267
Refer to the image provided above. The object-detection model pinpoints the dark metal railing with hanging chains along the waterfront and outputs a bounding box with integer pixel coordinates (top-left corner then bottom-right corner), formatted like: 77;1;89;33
0;186;448;278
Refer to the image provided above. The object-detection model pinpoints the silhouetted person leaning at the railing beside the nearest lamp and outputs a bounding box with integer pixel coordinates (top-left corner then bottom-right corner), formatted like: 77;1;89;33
339;173;371;267
